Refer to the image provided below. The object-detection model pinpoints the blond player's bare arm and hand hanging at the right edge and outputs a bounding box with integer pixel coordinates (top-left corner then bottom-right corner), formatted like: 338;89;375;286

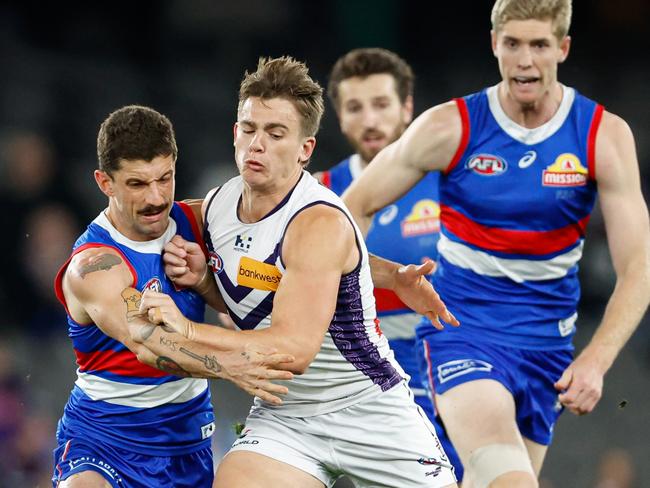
556;112;650;414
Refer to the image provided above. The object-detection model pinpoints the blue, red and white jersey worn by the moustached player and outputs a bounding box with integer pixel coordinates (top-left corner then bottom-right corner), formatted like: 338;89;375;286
55;203;214;456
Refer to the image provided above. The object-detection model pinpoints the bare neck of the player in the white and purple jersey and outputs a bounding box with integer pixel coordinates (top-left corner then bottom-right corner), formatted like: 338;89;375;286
237;170;302;224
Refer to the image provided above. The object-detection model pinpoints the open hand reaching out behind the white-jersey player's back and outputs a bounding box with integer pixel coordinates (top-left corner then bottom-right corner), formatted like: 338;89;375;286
369;254;460;329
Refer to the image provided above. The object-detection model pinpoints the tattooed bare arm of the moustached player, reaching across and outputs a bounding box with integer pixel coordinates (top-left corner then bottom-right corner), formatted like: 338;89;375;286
63;247;291;401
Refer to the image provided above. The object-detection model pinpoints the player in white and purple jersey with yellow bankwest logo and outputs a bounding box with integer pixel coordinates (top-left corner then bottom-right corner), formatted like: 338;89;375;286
134;57;456;488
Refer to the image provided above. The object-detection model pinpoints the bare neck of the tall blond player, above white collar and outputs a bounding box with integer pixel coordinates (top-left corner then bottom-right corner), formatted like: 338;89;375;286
497;82;564;129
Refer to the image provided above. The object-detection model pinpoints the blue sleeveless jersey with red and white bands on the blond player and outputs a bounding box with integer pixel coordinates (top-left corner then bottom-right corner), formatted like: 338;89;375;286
418;87;603;350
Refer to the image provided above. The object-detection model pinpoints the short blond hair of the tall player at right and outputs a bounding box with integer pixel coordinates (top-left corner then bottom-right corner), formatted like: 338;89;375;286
492;0;571;40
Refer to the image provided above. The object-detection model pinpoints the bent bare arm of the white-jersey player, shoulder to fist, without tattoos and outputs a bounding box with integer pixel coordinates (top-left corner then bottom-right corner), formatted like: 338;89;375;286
140;205;359;373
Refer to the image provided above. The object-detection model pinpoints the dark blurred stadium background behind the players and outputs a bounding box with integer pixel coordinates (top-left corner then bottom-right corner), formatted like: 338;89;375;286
0;0;650;488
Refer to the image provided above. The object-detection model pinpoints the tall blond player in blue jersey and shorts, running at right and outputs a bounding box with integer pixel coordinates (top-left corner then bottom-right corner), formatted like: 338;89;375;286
343;0;650;487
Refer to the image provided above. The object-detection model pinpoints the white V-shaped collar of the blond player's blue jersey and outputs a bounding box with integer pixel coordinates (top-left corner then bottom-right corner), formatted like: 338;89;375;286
487;85;576;144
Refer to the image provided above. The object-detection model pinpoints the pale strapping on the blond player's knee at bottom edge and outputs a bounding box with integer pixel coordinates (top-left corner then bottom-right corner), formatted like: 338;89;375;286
467;444;538;488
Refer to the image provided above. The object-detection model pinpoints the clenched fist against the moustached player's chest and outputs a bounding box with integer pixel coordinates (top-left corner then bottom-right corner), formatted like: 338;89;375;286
163;235;208;288
